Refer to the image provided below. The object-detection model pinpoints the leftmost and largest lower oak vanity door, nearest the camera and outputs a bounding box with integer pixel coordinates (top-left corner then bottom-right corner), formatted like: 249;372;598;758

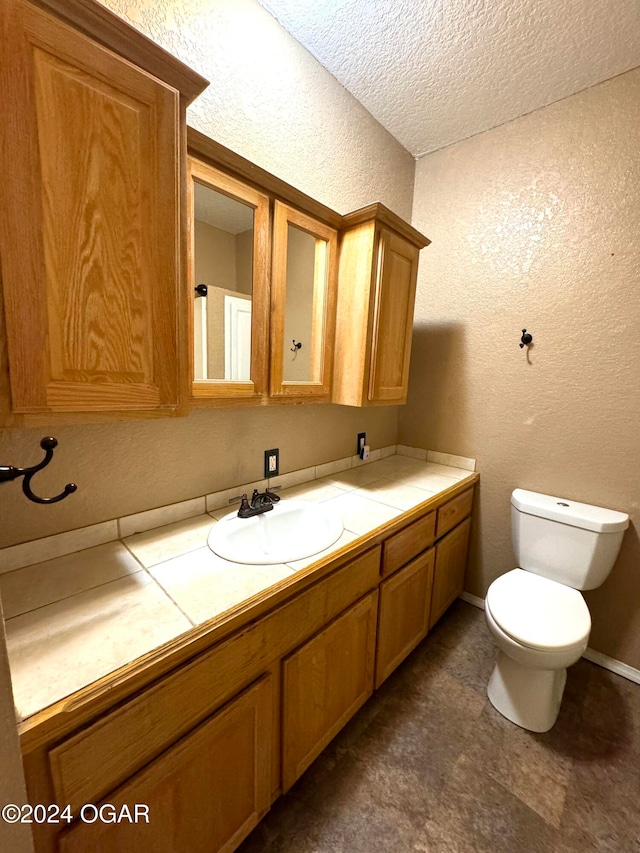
59;676;272;853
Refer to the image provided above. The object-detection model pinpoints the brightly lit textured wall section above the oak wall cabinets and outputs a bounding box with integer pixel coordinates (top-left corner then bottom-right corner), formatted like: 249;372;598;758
102;0;413;219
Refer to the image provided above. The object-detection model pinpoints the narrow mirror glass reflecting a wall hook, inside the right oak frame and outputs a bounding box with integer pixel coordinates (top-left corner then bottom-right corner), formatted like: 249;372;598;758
282;223;327;382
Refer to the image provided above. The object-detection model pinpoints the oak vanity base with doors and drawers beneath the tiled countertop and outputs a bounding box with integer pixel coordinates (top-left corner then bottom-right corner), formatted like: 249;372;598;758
12;472;478;853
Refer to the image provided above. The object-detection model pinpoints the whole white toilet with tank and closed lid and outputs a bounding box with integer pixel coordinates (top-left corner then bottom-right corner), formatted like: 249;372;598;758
485;489;629;732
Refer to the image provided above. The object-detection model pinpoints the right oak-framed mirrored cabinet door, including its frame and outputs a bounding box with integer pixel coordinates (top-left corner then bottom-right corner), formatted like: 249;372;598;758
270;201;338;397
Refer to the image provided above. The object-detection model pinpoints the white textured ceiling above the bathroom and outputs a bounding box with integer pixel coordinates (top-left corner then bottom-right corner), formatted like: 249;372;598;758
260;0;640;157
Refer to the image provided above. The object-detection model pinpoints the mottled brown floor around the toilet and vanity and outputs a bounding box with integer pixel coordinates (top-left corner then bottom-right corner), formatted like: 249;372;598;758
239;601;640;853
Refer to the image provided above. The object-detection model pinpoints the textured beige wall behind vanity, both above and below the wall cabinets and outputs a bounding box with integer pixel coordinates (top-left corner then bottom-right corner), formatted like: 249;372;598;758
0;0;414;547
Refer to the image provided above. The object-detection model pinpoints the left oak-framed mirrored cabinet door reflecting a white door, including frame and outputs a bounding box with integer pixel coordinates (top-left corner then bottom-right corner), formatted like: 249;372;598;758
188;158;269;398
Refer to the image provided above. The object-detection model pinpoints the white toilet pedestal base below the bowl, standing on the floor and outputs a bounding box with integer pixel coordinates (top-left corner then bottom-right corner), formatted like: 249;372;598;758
487;652;567;732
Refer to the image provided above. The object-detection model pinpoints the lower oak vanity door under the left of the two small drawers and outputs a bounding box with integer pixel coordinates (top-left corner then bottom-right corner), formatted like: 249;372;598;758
376;548;435;687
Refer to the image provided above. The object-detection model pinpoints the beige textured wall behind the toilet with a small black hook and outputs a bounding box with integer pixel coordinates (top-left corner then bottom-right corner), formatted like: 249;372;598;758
400;69;640;668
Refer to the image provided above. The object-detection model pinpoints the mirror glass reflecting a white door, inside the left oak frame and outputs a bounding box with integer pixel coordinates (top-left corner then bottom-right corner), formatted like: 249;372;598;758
193;180;254;381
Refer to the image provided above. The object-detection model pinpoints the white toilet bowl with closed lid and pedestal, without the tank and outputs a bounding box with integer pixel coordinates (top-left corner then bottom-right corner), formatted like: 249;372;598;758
485;569;591;732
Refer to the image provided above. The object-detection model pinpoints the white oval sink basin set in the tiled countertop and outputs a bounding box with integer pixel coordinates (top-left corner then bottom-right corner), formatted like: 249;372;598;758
207;500;344;566
